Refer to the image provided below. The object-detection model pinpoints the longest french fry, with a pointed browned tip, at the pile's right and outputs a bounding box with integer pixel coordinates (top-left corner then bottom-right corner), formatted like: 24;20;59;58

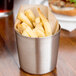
38;8;52;36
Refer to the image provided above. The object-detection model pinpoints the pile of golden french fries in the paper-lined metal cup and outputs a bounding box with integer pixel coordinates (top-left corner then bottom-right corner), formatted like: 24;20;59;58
16;8;57;37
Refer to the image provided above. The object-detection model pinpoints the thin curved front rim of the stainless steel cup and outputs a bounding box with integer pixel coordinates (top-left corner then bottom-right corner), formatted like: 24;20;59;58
14;24;61;39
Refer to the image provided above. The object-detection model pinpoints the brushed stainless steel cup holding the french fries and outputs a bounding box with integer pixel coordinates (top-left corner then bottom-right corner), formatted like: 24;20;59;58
16;25;60;74
